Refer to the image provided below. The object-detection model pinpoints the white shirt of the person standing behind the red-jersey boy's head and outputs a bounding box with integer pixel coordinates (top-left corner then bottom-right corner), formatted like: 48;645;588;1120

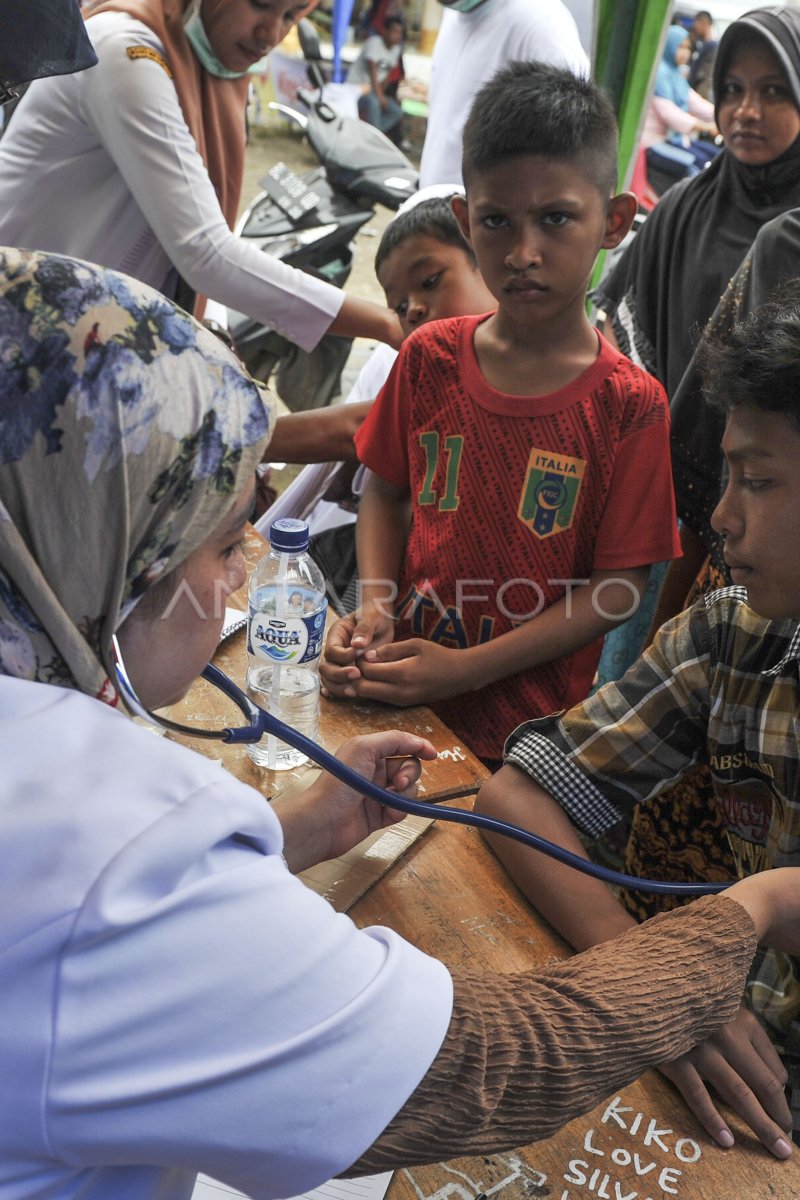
420;0;589;187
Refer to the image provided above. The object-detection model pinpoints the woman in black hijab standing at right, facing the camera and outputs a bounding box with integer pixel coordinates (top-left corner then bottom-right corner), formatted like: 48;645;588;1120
595;8;800;919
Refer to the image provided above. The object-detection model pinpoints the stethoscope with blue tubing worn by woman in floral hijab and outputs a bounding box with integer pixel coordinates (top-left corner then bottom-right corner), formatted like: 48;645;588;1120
112;637;730;896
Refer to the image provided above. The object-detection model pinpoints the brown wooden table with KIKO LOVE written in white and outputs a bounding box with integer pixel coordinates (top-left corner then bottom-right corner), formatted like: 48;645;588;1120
173;535;800;1200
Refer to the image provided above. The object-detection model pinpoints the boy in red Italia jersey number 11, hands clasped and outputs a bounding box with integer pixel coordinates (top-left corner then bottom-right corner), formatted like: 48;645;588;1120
321;62;678;762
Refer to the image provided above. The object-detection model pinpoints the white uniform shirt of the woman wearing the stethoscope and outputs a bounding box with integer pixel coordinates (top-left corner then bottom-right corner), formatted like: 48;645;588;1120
0;677;452;1200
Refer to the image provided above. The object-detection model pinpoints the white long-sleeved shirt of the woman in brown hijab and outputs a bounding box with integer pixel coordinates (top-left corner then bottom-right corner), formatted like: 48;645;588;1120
0;12;344;350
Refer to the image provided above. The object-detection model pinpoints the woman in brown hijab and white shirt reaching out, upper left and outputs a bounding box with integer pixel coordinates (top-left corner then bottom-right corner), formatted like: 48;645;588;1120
0;0;401;350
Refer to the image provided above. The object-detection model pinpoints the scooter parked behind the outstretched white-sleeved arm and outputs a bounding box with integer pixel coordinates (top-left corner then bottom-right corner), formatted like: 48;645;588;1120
228;37;419;412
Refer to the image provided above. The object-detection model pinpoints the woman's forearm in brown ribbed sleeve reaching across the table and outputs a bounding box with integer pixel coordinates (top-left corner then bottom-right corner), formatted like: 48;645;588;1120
343;869;800;1175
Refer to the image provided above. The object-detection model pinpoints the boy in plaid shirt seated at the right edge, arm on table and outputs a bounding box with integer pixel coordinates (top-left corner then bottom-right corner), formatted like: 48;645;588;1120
477;289;800;1157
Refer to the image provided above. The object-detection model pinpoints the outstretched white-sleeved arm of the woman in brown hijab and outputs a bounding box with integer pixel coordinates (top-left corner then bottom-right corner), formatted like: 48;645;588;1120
84;26;402;350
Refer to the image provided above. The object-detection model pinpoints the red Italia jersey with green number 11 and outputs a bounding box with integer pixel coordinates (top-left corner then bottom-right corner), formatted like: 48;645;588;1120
356;317;680;758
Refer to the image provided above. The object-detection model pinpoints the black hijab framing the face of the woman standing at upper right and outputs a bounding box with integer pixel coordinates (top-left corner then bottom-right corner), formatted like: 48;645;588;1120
595;8;800;396
